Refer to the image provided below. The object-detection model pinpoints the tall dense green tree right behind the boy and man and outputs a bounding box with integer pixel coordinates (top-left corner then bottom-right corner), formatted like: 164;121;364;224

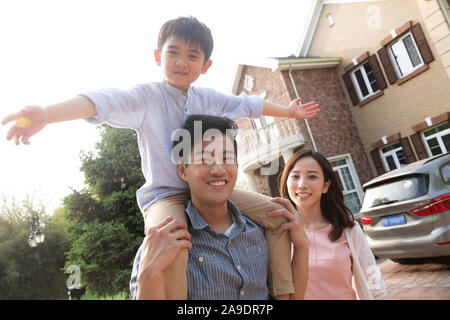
64;125;145;296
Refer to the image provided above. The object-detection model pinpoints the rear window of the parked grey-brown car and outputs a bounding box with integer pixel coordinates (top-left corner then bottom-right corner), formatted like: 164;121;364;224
361;175;427;210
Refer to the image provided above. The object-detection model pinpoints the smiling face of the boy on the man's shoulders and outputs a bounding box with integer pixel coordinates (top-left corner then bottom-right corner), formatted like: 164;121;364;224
154;36;212;91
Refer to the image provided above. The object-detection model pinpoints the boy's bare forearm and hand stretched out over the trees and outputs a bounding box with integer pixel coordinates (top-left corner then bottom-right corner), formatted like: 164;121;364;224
2;96;96;145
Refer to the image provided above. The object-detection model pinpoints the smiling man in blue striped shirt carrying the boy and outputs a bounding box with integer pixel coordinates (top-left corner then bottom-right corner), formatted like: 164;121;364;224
130;115;309;300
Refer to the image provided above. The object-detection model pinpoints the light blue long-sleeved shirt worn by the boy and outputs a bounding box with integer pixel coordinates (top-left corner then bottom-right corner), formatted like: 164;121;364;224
82;81;262;212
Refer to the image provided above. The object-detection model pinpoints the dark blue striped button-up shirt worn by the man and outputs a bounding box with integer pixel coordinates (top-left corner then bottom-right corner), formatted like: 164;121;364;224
130;201;269;300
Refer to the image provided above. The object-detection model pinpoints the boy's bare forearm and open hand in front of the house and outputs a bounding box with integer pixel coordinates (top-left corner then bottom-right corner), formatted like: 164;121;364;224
263;98;320;119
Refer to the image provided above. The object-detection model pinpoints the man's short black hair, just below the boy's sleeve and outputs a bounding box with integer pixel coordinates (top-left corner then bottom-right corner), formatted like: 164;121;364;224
172;114;238;163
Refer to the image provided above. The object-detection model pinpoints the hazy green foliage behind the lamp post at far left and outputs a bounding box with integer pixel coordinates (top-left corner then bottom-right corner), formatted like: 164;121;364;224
0;199;69;299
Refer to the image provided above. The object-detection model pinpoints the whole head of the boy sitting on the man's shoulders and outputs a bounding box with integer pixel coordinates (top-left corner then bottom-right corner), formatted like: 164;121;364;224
154;17;214;90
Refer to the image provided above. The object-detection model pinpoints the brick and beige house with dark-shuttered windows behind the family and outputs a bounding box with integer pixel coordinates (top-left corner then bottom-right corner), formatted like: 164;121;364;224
232;0;450;213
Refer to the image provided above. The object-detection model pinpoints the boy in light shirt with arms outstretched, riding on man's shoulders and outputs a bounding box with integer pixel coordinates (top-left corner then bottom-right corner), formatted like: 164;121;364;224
2;17;319;299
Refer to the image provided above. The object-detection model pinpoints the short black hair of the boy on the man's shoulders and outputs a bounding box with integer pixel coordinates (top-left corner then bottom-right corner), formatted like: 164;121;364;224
158;16;214;61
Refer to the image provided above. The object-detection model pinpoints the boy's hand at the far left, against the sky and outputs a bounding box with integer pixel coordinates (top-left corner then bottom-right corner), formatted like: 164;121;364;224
2;106;48;145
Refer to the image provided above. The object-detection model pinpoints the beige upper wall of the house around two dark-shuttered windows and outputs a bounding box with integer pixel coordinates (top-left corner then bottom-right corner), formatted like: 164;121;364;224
308;0;450;168
